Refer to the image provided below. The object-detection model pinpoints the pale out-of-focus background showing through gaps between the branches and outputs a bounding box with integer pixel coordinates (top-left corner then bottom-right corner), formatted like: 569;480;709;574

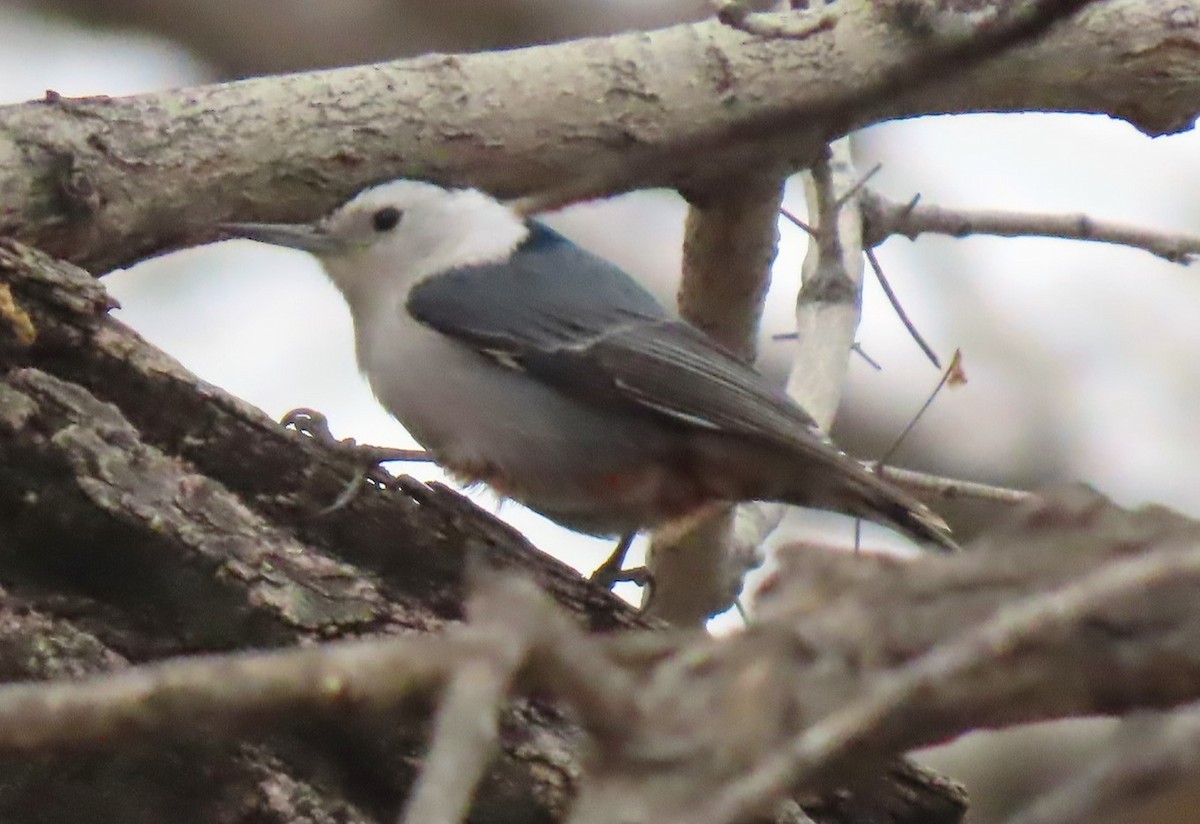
0;0;1200;824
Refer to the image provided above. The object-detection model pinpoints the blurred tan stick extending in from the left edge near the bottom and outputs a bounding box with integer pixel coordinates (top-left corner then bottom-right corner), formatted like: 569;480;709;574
0;632;451;752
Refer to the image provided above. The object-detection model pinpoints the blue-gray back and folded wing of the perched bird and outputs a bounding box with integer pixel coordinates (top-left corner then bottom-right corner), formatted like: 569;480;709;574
407;223;827;449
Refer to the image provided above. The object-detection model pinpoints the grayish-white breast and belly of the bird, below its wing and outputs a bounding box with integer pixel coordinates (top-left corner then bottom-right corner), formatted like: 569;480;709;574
356;296;681;531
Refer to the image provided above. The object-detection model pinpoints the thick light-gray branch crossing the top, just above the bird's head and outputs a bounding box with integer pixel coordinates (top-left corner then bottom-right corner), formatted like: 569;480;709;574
0;0;1200;271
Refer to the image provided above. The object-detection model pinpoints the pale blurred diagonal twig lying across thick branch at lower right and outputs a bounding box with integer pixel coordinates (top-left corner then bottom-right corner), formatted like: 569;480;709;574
681;546;1200;824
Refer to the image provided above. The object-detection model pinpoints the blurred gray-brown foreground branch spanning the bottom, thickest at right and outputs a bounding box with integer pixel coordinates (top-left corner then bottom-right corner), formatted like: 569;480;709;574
0;488;1200;824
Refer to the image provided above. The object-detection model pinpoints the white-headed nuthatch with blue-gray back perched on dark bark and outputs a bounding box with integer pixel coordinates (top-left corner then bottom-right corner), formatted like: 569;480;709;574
223;179;955;580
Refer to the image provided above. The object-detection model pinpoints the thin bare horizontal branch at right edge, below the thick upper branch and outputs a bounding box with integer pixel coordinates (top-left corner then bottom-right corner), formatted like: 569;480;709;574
863;192;1200;264
